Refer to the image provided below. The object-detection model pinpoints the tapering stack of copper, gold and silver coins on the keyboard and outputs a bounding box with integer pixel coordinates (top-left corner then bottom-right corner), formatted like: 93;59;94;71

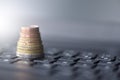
17;25;43;59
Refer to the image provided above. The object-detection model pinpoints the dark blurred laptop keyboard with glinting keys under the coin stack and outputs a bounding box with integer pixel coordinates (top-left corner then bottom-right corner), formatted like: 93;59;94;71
0;48;120;80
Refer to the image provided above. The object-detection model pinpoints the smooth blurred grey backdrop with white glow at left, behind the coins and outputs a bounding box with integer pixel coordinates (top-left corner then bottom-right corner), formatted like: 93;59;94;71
0;0;120;47
